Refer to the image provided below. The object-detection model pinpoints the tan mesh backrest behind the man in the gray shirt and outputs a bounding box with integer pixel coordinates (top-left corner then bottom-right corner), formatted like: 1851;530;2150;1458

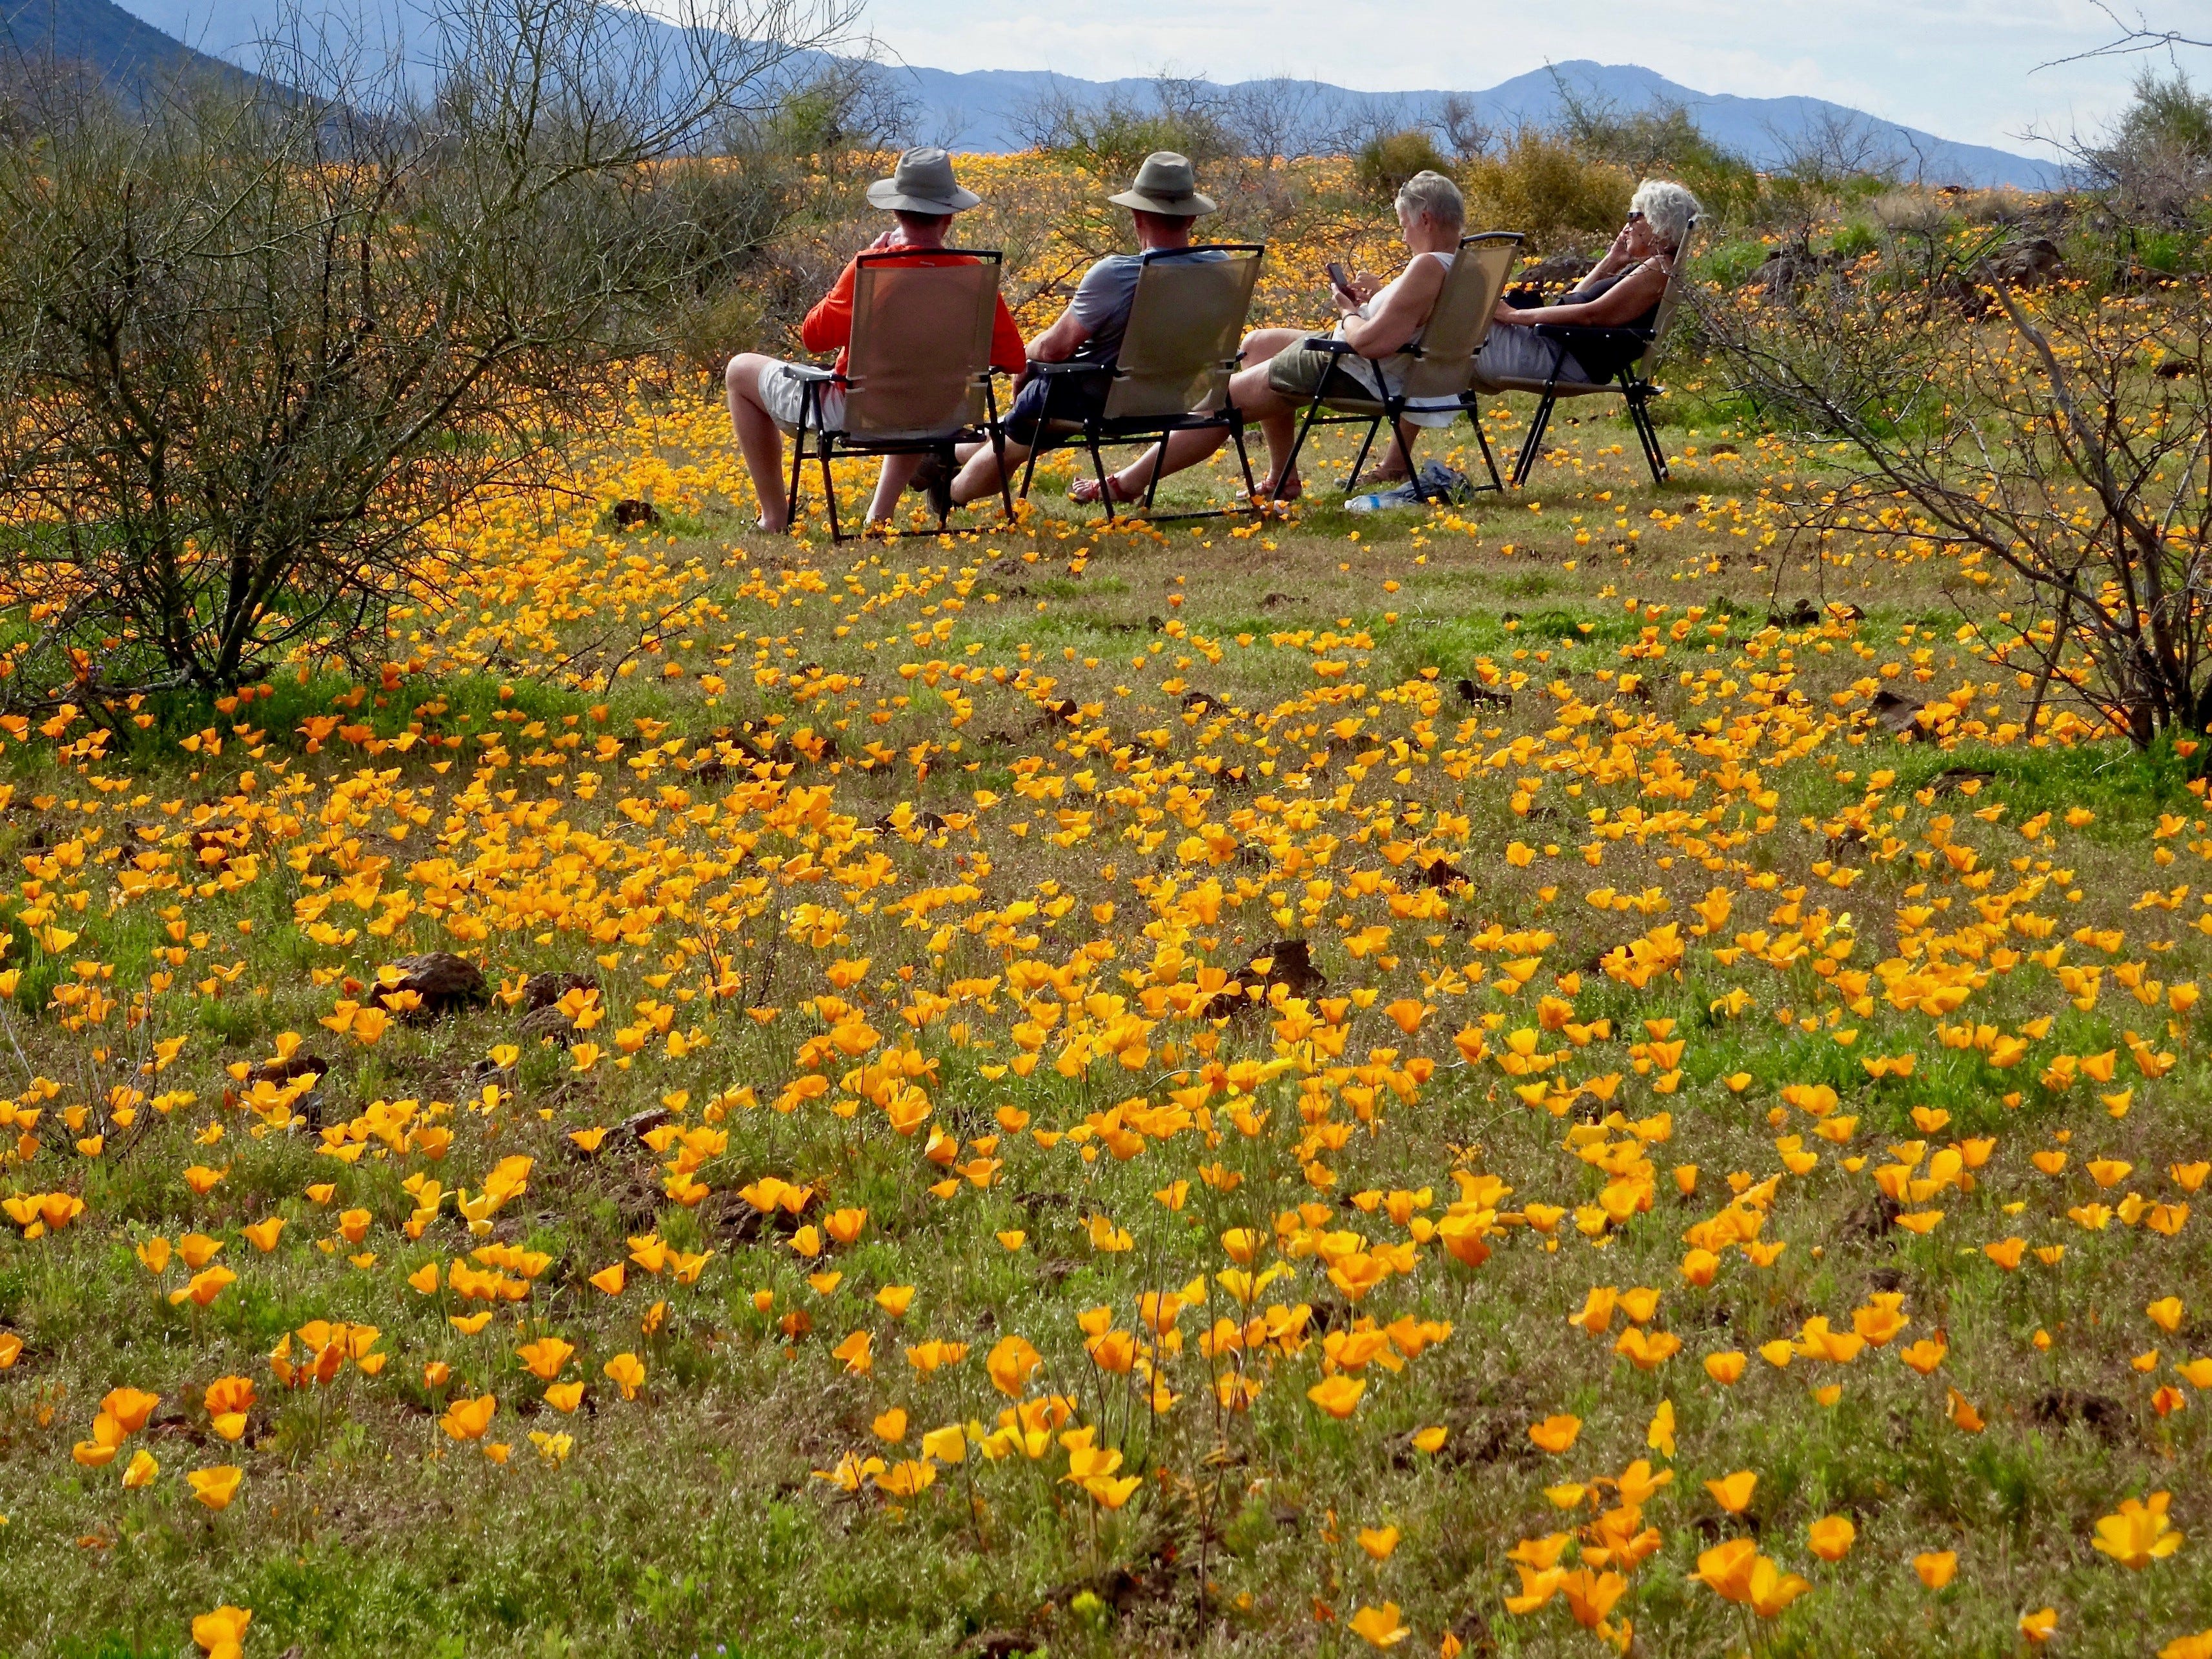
1104;243;1265;420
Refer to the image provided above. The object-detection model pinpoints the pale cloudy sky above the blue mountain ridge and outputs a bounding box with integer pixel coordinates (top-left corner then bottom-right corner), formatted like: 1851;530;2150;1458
849;0;2212;152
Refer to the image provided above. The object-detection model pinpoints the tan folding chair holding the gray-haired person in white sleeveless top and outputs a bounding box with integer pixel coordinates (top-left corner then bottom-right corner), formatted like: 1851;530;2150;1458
1283;230;1522;500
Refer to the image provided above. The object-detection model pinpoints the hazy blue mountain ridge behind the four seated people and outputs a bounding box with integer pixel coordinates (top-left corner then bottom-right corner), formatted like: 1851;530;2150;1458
896;60;2060;190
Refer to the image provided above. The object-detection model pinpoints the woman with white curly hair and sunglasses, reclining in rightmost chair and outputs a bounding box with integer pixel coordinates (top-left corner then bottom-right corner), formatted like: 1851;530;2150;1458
1476;179;1699;385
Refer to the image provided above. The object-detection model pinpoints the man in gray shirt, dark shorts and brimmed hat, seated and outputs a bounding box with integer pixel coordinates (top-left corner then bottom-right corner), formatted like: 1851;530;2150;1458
953;150;1219;502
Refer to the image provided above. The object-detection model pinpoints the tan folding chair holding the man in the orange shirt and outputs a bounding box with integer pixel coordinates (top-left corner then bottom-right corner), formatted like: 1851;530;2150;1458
789;248;1013;542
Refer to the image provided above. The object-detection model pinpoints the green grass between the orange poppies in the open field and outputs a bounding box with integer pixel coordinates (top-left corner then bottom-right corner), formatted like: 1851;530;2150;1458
0;400;2212;1659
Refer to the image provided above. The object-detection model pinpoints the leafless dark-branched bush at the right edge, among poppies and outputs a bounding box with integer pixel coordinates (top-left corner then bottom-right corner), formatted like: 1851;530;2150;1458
1703;255;2212;746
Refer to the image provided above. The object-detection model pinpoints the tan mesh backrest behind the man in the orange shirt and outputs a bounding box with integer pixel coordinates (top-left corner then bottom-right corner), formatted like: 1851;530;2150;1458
845;248;998;440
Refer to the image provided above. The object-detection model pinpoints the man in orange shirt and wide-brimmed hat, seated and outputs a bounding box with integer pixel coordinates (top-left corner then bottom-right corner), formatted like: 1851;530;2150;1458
724;146;1026;531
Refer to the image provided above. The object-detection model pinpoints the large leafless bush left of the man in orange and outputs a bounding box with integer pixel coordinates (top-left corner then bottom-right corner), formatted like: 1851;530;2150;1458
0;0;845;706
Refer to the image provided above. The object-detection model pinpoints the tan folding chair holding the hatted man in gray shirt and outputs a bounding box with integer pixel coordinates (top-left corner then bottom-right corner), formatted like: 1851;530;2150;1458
1022;241;1268;520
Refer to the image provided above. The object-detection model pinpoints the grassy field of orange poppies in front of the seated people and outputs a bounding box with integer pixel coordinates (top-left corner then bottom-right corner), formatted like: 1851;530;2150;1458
0;270;2212;1659
